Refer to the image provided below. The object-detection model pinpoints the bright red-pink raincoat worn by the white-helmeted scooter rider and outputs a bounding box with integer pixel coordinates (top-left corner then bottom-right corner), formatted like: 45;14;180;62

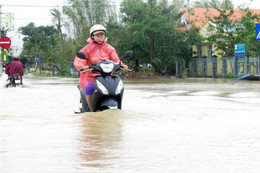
74;38;120;90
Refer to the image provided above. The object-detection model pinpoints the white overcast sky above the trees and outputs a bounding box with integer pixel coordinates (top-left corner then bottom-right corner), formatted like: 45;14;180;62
0;0;260;53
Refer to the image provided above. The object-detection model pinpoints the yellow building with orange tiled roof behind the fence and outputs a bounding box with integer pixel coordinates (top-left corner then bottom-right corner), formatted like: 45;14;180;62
181;8;260;76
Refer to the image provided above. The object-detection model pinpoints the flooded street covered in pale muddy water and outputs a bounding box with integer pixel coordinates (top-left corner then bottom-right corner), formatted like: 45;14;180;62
0;76;260;173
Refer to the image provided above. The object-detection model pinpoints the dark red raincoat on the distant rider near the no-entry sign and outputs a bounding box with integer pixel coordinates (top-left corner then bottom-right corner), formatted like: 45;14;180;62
4;58;25;77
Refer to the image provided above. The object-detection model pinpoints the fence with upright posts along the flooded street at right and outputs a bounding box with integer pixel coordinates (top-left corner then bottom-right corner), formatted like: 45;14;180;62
189;56;260;77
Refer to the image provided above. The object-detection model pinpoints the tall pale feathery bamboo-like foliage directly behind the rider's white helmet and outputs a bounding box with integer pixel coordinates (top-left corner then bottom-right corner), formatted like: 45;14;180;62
63;0;117;44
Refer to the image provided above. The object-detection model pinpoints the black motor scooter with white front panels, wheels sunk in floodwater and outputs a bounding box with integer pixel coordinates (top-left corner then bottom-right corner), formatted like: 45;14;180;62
75;50;133;113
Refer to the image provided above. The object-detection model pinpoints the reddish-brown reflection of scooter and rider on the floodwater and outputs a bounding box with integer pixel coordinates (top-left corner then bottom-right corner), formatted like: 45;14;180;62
79;110;125;167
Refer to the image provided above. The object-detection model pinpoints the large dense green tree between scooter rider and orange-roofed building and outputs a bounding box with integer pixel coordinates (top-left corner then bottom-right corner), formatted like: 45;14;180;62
121;0;183;73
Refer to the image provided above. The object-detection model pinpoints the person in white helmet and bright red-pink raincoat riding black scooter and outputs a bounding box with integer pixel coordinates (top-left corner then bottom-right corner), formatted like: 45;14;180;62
74;24;128;111
